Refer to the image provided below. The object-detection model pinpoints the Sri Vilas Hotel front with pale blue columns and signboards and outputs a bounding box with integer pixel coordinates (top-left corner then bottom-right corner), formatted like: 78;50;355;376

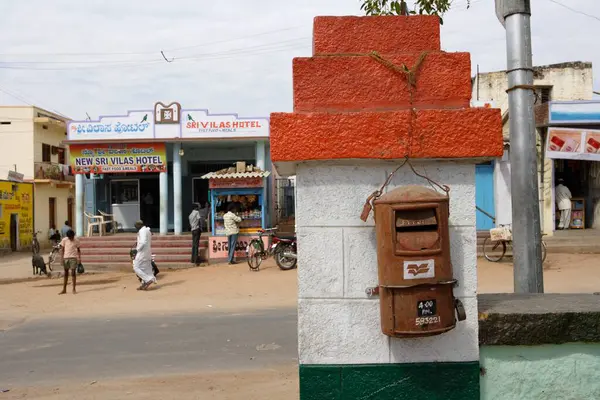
67;103;272;256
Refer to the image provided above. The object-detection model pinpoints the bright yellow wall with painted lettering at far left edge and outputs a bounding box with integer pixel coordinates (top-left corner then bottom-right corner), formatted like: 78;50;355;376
0;181;34;250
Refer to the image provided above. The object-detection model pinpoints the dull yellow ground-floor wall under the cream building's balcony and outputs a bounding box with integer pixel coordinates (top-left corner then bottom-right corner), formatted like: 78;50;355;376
35;183;75;246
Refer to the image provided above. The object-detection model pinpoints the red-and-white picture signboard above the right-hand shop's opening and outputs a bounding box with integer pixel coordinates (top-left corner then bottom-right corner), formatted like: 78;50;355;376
546;128;600;161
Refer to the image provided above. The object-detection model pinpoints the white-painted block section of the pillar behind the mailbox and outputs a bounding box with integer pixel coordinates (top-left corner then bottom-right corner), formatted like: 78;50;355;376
296;161;479;364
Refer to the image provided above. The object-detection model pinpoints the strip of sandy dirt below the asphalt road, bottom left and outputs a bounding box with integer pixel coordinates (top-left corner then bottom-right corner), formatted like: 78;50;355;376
0;366;298;400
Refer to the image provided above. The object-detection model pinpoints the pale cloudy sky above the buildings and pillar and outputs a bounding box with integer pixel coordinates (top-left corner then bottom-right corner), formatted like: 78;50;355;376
0;0;600;119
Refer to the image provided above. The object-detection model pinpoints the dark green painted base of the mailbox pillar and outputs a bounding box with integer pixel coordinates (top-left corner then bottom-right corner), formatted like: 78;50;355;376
300;362;479;400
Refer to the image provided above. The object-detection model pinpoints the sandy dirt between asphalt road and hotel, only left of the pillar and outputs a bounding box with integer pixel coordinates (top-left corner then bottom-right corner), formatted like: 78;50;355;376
0;260;297;330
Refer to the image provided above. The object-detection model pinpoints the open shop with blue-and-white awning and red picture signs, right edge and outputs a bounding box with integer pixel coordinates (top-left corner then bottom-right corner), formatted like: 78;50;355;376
545;101;600;230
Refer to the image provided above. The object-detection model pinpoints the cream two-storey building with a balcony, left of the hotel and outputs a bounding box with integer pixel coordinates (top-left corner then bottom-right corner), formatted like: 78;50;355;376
0;106;75;247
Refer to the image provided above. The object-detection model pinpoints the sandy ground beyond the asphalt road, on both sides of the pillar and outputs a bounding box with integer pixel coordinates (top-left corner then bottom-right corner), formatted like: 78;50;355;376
0;254;600;330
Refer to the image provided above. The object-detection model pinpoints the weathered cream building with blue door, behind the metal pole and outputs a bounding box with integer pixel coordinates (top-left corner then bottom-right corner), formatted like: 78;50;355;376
472;61;593;235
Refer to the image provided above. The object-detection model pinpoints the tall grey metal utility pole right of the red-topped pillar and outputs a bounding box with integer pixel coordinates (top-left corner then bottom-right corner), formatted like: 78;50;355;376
496;0;544;293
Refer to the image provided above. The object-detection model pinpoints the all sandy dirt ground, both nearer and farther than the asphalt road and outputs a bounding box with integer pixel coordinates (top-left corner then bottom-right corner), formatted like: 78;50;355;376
0;254;600;400
